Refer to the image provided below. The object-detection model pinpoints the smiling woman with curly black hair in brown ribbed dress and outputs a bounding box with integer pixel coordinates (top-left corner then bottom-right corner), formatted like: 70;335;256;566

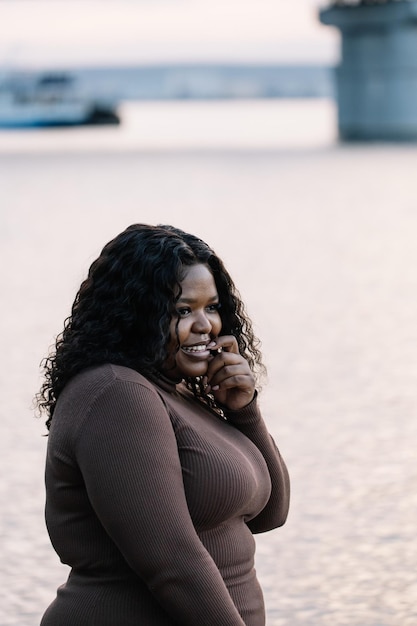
39;224;289;626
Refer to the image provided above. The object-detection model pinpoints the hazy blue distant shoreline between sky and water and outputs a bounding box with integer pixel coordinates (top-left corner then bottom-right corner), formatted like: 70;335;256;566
2;63;335;100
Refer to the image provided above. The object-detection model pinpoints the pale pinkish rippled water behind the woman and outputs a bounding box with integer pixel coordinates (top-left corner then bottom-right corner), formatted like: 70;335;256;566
0;101;417;626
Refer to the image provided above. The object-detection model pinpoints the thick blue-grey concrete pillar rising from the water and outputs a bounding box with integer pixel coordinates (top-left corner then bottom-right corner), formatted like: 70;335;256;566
320;0;417;141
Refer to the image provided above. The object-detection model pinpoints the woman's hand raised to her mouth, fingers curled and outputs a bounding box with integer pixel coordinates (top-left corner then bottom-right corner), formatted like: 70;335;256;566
204;335;255;411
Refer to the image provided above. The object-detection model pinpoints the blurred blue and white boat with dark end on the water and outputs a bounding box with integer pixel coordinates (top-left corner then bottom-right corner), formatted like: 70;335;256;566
0;72;120;128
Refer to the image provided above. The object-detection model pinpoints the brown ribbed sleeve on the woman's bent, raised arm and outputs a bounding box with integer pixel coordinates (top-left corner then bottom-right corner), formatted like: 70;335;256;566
225;394;290;533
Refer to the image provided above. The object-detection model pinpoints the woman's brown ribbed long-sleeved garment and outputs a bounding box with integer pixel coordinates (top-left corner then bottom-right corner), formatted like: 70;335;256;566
42;365;289;626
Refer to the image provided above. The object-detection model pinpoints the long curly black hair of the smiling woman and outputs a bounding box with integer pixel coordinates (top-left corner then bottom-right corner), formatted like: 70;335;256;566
37;224;264;429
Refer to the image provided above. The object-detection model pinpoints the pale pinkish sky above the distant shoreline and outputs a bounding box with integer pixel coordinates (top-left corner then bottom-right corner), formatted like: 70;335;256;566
0;0;339;67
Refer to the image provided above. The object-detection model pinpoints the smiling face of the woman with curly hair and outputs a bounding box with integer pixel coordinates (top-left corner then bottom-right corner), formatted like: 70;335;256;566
164;264;222;380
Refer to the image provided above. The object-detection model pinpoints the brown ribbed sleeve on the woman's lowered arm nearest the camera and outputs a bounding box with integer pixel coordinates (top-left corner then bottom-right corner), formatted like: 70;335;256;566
75;380;247;626
